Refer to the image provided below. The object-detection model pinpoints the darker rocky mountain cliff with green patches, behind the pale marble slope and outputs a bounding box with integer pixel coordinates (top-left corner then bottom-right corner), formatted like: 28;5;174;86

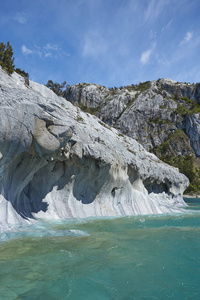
65;79;200;191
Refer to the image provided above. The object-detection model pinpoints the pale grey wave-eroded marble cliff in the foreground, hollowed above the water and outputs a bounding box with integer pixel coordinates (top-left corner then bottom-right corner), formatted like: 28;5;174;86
0;69;188;230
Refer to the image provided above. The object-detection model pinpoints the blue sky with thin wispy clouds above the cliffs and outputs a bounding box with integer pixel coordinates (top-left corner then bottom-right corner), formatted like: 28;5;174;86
0;0;200;87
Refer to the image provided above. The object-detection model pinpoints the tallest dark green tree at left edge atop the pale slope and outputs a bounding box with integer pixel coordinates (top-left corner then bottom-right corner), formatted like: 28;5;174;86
0;42;15;75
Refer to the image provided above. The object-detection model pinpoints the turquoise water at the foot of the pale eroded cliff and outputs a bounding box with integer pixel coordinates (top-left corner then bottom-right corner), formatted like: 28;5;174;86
0;199;200;300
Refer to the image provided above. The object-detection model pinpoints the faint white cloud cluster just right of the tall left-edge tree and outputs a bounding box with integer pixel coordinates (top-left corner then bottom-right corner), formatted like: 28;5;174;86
22;43;70;58
